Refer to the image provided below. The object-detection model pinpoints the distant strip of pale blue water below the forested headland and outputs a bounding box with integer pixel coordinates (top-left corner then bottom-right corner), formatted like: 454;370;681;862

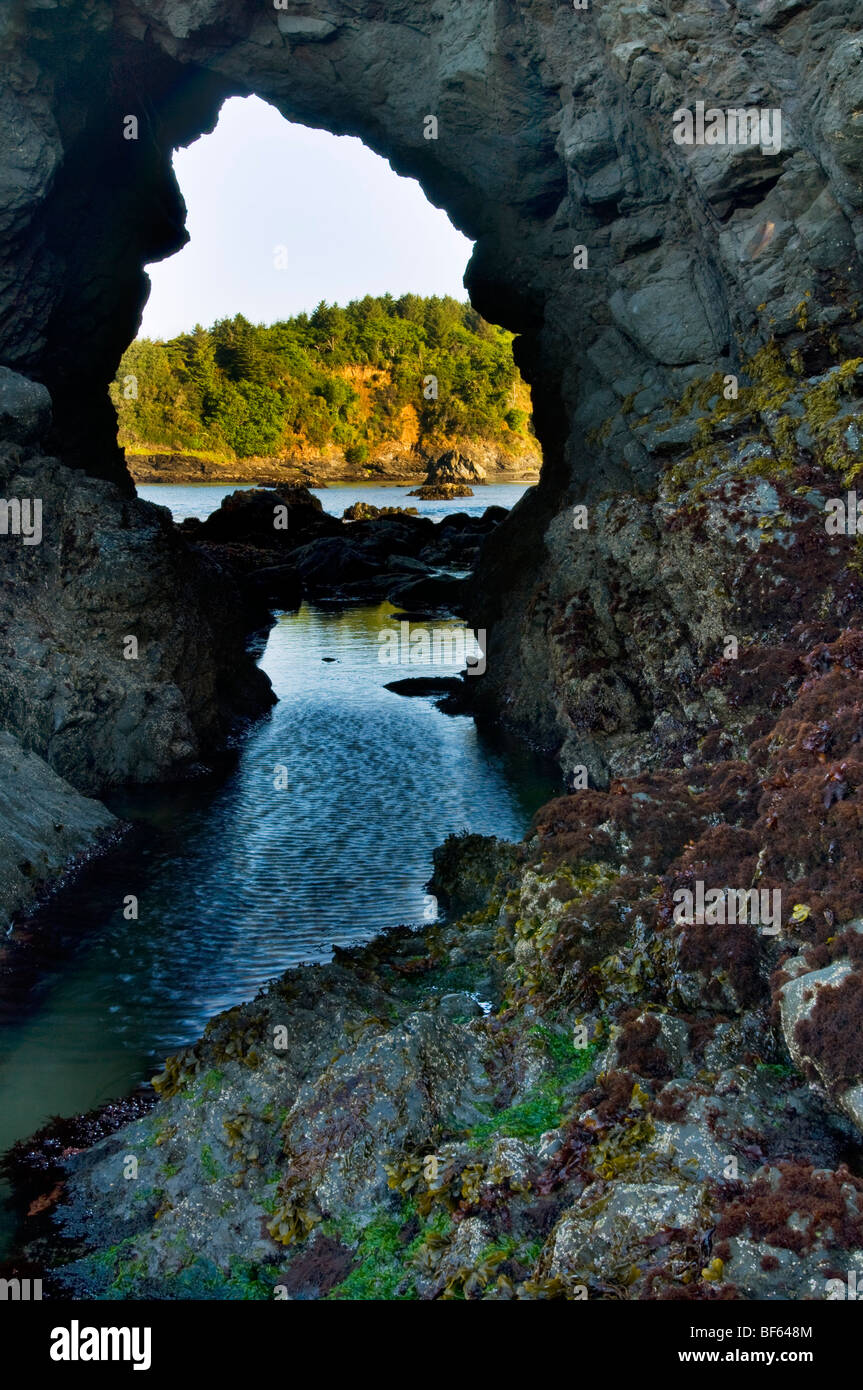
138;482;529;521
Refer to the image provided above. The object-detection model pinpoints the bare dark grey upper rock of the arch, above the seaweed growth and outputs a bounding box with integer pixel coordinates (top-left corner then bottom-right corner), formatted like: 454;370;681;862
0;0;863;769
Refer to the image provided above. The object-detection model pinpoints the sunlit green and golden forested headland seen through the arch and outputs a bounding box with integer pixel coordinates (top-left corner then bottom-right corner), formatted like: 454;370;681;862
111;295;538;475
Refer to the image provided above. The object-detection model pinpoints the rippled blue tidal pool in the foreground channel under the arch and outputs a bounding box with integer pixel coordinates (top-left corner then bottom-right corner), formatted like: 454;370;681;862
0;583;557;1245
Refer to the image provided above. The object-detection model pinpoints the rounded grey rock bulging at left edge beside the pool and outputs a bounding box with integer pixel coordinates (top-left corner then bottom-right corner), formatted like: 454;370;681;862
0;444;272;792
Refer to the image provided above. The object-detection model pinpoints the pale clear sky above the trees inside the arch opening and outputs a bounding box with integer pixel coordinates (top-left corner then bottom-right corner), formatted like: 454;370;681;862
139;97;472;338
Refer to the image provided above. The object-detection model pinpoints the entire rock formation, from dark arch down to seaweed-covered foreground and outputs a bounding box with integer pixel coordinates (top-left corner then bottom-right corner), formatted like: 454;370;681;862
0;0;863;1301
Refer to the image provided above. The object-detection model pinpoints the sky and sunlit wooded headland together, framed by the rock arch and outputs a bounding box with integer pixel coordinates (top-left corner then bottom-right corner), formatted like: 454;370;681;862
111;97;538;497
